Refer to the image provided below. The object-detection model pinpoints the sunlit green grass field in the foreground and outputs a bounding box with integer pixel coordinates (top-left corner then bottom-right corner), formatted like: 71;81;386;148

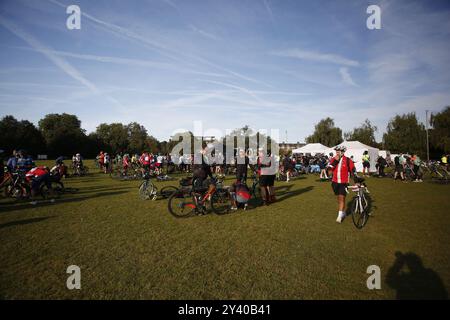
0;163;450;299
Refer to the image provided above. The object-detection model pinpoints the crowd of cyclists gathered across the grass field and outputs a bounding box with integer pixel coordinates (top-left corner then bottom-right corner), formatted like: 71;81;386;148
0;146;449;223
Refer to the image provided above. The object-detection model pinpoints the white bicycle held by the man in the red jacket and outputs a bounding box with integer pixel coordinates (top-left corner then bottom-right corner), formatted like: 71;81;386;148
346;179;370;229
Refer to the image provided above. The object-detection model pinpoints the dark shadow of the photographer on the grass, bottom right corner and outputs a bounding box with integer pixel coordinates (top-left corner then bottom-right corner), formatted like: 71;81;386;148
386;251;448;300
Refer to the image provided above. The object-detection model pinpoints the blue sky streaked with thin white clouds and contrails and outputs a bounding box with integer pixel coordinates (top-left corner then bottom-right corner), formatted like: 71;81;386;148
0;0;450;142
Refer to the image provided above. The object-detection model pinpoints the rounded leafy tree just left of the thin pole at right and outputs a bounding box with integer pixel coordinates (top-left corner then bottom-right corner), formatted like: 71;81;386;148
383;113;426;157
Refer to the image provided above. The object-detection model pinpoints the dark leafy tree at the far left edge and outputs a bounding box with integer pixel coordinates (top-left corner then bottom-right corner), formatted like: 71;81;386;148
0;116;47;156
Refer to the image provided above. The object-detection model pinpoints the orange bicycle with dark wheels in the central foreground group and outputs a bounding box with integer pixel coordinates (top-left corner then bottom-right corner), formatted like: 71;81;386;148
167;176;231;218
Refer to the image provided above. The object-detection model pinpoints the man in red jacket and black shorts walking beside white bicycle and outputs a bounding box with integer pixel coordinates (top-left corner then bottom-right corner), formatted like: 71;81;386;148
329;146;356;223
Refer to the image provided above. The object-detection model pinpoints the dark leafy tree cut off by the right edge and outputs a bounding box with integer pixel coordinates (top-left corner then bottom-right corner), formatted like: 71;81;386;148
430;106;450;153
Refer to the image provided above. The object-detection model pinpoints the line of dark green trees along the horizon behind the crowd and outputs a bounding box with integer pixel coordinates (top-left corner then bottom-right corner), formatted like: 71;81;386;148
0;106;450;158
